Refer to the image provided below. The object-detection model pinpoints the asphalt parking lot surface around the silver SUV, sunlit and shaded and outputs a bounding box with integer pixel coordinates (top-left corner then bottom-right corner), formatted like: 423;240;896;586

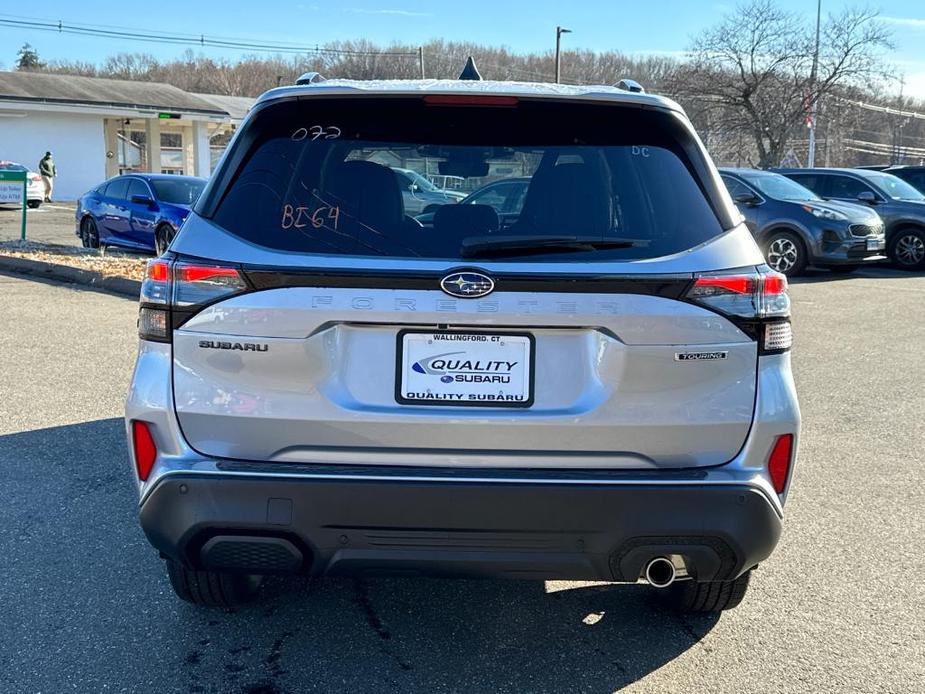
0;270;925;694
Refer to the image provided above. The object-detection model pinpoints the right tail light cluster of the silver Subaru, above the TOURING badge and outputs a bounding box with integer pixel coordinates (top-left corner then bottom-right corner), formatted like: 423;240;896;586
686;271;793;354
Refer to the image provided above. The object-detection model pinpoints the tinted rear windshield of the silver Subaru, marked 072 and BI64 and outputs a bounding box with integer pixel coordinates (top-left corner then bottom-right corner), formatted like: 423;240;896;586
206;97;723;261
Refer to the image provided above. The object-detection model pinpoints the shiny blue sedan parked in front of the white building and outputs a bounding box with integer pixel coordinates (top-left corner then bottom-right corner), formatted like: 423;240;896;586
76;174;206;255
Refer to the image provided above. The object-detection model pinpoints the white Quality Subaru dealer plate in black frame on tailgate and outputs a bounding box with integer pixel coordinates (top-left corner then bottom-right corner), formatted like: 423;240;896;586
395;330;534;407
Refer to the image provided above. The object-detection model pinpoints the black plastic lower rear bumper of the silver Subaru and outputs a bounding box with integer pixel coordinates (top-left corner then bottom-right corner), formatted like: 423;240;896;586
140;466;781;582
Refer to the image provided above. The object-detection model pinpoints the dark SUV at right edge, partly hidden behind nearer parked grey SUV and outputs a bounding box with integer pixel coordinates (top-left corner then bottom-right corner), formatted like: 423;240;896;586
779;169;925;270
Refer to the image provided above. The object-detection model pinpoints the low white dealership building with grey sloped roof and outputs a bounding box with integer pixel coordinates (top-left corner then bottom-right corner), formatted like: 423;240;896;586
0;71;254;200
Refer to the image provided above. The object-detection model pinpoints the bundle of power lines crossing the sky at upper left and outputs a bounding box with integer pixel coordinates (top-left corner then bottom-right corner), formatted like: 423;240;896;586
0;15;418;58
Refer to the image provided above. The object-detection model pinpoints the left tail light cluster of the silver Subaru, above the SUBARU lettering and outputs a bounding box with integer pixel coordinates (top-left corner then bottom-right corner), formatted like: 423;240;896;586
138;258;249;342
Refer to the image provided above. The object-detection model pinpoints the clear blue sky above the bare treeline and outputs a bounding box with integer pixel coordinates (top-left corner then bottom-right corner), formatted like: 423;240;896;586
0;0;925;99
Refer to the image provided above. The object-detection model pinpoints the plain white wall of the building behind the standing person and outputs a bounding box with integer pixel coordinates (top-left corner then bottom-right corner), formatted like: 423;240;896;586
0;108;106;200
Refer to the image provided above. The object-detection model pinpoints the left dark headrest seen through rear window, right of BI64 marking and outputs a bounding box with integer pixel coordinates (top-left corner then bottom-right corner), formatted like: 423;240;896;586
324;161;405;228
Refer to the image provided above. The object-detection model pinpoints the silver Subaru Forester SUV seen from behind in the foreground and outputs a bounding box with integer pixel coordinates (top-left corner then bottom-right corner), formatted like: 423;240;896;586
126;75;800;611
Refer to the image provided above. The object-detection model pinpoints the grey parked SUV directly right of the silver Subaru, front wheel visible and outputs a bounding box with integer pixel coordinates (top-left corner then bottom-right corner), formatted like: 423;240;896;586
720;169;886;276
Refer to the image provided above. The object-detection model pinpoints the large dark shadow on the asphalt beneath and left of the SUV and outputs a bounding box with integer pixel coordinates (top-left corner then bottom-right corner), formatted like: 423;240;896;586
0;418;717;694
